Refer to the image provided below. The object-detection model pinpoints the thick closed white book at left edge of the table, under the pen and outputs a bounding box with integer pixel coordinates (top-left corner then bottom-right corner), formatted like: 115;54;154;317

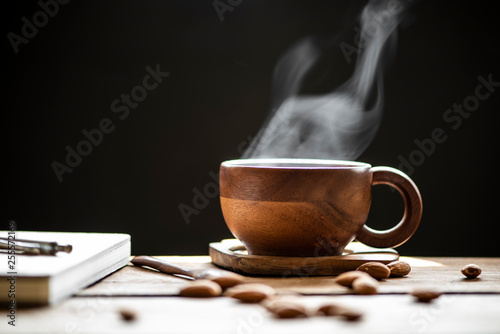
0;231;130;305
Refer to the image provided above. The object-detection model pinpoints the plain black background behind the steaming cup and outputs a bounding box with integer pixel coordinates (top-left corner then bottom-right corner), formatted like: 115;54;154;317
0;0;500;256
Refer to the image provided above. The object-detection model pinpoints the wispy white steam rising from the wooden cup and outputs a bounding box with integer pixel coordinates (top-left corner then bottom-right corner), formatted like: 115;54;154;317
243;0;403;160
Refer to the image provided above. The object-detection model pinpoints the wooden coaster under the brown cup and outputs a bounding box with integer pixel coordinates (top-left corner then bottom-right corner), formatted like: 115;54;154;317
209;239;399;277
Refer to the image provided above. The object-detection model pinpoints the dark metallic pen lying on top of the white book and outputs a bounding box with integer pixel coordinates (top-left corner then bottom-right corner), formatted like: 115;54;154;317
0;237;73;255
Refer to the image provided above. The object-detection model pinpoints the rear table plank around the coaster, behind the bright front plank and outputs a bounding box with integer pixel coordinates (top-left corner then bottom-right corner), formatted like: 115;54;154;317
78;256;500;297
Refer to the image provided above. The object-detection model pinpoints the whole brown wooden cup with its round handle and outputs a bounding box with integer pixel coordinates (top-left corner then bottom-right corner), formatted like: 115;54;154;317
220;159;422;256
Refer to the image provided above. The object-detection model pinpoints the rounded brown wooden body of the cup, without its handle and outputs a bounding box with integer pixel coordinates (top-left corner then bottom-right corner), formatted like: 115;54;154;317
219;159;372;256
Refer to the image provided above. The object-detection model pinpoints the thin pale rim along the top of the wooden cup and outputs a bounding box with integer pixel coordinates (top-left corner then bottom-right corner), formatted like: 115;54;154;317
221;158;371;169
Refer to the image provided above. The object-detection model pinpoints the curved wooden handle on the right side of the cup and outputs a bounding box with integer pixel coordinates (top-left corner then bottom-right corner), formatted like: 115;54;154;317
356;167;422;248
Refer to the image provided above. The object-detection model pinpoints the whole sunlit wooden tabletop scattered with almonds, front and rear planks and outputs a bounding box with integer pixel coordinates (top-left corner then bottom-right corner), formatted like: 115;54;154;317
0;256;500;334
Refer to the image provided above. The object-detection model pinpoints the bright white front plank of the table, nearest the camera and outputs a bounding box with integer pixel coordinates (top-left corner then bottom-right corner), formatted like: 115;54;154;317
0;295;500;334
